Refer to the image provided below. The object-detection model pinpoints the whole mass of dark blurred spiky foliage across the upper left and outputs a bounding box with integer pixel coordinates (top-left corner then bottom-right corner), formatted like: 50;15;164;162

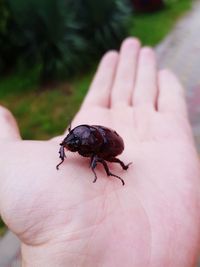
0;0;130;81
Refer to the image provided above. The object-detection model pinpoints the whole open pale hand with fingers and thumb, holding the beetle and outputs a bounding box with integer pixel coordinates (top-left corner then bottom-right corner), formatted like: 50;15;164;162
0;38;200;267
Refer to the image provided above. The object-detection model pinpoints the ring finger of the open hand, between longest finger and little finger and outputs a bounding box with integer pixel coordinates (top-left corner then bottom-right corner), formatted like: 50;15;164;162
132;47;157;107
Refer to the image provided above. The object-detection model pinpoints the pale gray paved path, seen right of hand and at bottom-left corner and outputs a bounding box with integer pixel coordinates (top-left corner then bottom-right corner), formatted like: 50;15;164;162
0;1;200;267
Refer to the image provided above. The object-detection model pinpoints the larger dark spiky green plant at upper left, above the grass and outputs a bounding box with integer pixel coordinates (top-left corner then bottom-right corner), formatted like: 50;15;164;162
5;0;85;80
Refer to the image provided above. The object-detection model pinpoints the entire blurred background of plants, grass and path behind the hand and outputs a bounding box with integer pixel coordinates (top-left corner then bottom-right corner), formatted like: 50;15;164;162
0;0;200;266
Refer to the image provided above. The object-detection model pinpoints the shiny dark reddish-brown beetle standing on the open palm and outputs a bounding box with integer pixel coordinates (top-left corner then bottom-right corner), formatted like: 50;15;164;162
56;124;131;185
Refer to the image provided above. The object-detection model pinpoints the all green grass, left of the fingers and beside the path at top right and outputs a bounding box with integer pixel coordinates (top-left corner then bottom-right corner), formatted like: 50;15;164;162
0;0;194;235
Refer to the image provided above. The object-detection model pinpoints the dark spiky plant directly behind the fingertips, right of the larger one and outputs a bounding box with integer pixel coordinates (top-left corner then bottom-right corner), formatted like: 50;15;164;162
71;0;131;56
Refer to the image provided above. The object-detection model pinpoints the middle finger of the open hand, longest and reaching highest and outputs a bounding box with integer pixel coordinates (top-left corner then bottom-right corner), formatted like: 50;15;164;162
111;38;140;107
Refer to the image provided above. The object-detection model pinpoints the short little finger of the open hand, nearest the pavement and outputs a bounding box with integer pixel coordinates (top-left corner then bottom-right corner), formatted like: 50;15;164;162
158;70;187;114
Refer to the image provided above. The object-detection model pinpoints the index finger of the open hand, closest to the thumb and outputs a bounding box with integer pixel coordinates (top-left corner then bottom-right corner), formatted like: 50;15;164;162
82;51;118;107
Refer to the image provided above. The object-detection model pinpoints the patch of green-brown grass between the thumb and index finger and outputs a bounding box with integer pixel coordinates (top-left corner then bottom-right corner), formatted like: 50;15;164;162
0;68;92;140
